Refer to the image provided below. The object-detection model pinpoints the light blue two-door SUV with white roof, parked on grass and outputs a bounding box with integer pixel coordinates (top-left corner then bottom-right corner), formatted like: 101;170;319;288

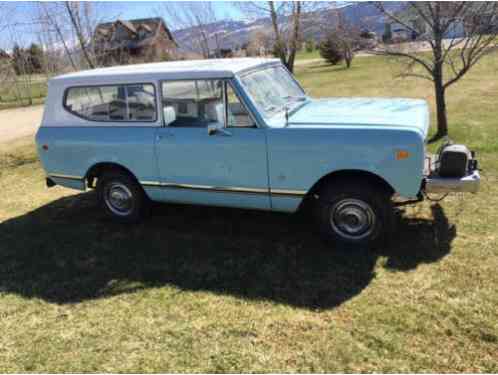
36;58;480;245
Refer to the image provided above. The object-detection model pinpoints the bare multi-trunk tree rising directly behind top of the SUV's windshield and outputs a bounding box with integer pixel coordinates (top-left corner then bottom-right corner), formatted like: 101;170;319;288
237;1;311;72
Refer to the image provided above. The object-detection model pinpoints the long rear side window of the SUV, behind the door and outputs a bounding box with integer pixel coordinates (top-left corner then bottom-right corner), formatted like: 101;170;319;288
64;84;157;122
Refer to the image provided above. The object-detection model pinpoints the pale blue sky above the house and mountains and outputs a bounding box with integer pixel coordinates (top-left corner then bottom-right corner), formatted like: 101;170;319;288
0;1;242;51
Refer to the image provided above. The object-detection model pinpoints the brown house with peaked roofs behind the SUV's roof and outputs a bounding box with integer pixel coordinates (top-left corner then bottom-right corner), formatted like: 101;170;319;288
93;17;178;66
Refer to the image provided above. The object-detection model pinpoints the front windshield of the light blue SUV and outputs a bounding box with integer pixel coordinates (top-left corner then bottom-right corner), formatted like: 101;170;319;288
240;66;306;118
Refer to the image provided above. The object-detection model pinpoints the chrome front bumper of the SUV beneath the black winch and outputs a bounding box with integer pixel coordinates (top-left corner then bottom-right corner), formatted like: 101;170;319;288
424;170;481;193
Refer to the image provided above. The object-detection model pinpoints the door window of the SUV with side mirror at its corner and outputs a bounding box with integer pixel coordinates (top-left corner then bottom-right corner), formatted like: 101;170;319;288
161;79;225;127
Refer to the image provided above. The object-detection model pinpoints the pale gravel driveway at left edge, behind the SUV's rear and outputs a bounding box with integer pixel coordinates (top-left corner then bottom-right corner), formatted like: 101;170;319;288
0;105;43;143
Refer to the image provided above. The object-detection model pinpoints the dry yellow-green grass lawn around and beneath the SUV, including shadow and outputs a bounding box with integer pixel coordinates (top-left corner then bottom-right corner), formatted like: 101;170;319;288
0;55;498;372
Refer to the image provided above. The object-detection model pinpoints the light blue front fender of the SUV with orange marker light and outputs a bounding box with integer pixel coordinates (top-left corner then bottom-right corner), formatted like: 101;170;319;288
268;126;425;211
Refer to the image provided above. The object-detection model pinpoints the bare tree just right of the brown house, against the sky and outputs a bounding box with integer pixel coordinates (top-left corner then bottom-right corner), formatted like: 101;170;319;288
158;1;220;59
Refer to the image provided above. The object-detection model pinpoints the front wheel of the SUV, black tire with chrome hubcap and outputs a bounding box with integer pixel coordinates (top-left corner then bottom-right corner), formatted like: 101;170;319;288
314;179;395;249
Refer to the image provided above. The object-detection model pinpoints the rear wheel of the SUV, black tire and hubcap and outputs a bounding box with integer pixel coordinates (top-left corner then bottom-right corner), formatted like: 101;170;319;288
97;171;149;223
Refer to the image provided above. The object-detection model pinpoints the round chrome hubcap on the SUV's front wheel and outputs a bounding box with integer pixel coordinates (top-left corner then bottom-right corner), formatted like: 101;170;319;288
330;199;376;240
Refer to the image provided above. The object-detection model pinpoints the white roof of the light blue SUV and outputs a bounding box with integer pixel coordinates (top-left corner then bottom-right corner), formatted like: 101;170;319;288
50;58;280;86
